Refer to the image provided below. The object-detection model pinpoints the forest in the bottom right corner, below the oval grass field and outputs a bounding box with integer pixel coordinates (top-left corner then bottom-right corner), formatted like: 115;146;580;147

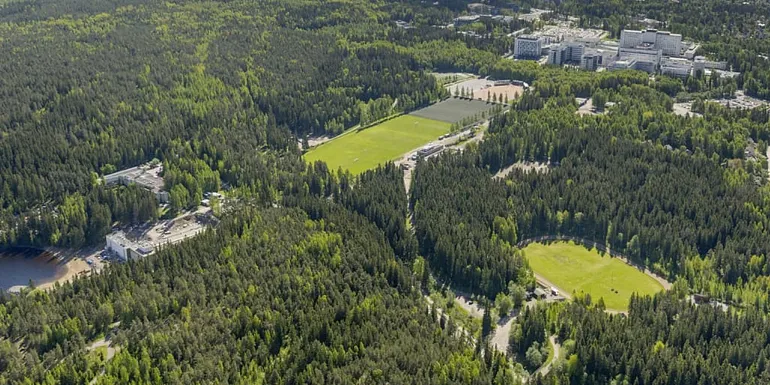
524;294;770;385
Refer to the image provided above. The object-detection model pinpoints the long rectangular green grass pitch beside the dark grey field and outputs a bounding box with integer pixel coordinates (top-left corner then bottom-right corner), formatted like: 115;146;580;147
304;115;451;174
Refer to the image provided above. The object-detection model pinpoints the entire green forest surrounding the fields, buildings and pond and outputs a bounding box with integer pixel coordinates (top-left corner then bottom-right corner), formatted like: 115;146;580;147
0;0;770;385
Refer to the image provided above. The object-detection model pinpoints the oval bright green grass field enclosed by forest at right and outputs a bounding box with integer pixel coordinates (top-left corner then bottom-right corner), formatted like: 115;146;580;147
523;242;663;311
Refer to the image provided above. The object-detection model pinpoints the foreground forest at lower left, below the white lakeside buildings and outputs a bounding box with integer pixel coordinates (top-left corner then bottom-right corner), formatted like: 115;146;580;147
0;201;510;384
